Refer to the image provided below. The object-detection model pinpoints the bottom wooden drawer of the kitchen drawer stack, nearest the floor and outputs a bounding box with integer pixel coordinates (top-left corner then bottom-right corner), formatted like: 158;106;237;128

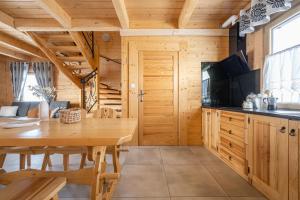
219;145;248;176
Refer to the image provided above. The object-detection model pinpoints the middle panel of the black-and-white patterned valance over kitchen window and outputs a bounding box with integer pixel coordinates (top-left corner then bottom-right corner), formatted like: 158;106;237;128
251;0;270;26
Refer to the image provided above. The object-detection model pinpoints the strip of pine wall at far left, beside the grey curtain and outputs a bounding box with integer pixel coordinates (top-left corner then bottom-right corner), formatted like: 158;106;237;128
0;59;13;106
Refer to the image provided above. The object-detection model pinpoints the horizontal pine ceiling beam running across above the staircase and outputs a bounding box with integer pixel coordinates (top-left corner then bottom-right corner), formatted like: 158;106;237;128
15;18;121;32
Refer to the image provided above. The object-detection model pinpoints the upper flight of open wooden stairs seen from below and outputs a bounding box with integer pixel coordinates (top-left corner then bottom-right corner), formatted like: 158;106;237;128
28;32;99;86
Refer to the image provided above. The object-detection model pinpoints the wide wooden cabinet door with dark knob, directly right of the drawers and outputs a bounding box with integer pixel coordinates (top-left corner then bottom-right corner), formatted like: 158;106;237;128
252;116;289;200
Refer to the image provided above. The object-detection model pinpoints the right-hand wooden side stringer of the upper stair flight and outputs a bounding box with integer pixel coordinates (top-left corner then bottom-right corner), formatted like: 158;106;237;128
69;31;97;70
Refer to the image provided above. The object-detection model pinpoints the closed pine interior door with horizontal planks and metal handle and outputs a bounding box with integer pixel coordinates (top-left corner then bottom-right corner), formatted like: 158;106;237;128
139;51;179;145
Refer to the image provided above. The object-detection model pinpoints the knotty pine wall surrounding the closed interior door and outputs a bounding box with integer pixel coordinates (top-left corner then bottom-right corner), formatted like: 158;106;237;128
122;36;228;145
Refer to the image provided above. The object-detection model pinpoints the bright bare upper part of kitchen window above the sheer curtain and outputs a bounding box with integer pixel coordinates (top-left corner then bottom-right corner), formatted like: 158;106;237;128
271;14;300;53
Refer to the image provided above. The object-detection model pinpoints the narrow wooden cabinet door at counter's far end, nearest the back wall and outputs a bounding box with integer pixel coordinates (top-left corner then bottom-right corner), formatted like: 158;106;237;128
202;108;211;148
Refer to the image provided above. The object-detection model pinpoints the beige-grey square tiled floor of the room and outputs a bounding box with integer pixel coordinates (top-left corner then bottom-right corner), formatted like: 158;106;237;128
0;147;266;200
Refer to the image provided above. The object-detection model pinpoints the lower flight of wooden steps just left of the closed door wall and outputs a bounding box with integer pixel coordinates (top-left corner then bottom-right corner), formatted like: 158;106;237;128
99;83;122;116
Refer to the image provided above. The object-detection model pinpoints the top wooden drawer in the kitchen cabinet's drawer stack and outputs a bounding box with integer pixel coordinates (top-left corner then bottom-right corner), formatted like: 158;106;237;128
221;111;246;128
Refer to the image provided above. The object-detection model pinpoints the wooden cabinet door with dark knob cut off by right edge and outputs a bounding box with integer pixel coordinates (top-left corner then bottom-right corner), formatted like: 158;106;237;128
289;121;300;200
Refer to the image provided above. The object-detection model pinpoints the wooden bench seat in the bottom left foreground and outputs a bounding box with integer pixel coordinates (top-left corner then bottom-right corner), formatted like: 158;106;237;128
0;177;66;200
